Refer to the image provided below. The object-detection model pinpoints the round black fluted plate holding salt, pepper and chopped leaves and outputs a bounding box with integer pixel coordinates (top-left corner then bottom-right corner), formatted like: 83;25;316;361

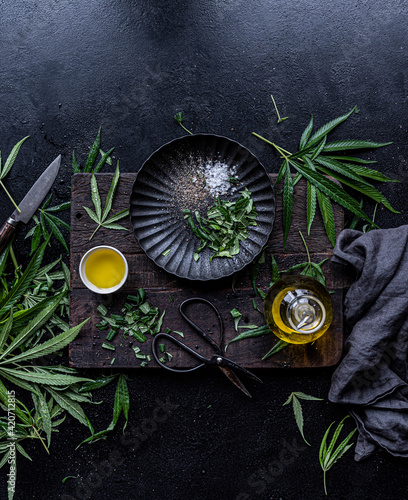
130;134;275;281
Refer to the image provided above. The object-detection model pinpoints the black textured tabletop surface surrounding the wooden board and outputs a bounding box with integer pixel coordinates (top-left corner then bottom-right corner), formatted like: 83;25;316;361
0;0;408;500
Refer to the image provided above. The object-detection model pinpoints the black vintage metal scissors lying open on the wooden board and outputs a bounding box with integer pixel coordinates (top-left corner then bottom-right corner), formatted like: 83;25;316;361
152;297;262;397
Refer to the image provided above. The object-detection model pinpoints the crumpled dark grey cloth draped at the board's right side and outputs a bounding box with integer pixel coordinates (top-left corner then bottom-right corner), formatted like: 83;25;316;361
329;226;408;461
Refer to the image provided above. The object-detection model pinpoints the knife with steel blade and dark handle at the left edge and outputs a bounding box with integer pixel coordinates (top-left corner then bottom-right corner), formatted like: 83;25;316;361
0;155;61;252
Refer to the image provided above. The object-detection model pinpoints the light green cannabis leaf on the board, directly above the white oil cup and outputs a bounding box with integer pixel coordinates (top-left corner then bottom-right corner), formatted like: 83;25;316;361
83;162;129;240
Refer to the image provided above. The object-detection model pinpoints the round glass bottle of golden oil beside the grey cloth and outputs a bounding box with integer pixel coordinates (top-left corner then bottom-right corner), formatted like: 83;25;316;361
264;275;333;344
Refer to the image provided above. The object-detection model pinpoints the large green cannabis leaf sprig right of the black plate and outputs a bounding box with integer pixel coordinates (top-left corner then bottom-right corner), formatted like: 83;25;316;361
253;106;399;247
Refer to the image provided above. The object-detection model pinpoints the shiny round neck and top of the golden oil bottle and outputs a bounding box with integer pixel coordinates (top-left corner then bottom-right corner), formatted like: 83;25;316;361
281;289;326;335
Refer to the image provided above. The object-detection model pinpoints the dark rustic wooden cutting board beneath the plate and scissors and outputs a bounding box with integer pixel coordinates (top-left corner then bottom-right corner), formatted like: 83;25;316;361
70;173;347;369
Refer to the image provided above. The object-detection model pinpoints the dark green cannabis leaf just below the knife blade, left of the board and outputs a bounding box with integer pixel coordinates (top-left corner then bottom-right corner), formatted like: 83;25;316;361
26;194;71;255
